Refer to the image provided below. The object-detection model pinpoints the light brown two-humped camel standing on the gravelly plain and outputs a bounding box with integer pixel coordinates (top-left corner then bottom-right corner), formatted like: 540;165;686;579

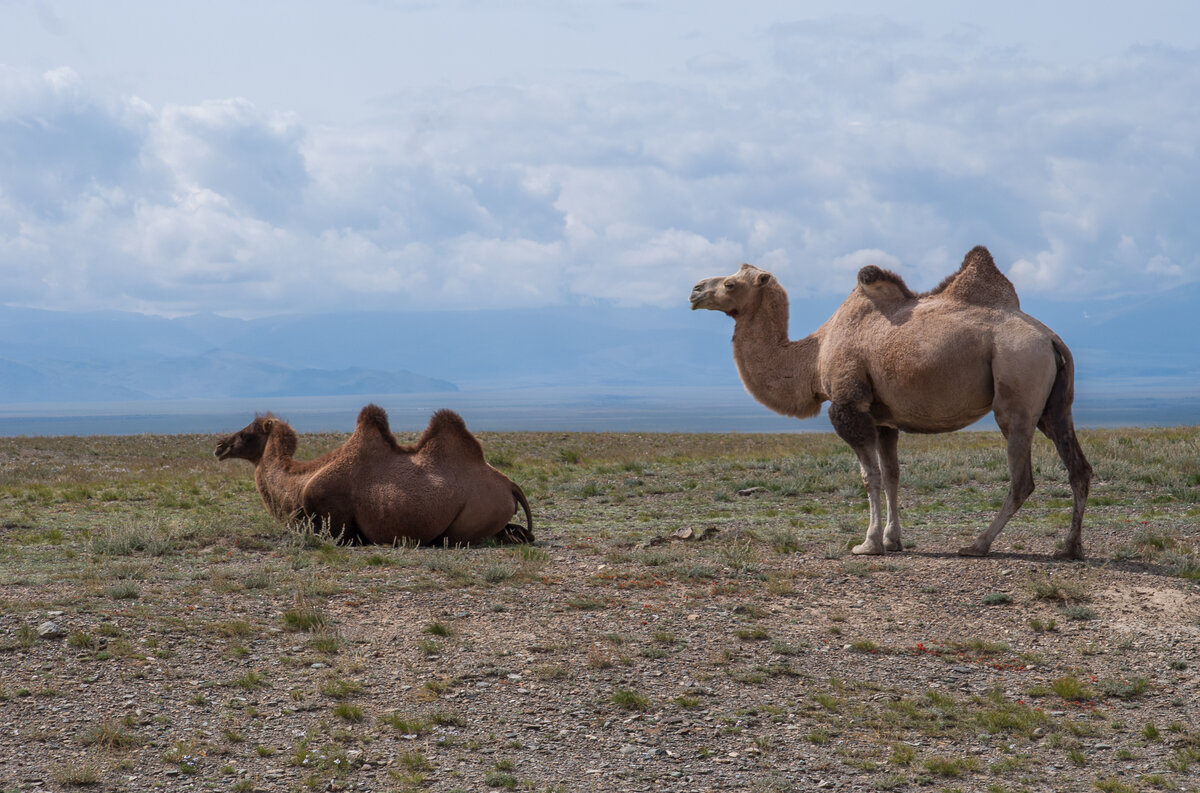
691;246;1092;559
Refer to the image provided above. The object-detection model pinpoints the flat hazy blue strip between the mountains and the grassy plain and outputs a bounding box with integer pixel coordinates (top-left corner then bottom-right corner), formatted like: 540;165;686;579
0;384;1200;437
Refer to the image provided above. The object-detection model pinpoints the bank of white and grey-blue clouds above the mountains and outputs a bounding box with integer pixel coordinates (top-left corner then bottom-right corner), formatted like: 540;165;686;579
0;26;1200;316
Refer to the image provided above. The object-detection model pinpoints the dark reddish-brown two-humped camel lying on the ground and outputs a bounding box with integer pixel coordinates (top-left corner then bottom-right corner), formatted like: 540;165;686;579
214;404;533;545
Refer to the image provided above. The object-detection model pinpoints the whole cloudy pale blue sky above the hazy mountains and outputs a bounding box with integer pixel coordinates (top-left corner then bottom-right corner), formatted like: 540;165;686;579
0;0;1200;318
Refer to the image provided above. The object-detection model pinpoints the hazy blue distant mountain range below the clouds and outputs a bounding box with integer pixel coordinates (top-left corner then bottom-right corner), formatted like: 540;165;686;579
0;284;1200;404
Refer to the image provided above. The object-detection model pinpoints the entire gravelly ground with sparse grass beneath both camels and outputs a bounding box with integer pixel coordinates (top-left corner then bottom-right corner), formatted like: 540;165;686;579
0;429;1200;792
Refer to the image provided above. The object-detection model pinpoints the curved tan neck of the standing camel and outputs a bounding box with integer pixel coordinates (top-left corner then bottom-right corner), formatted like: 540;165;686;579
733;289;824;419
